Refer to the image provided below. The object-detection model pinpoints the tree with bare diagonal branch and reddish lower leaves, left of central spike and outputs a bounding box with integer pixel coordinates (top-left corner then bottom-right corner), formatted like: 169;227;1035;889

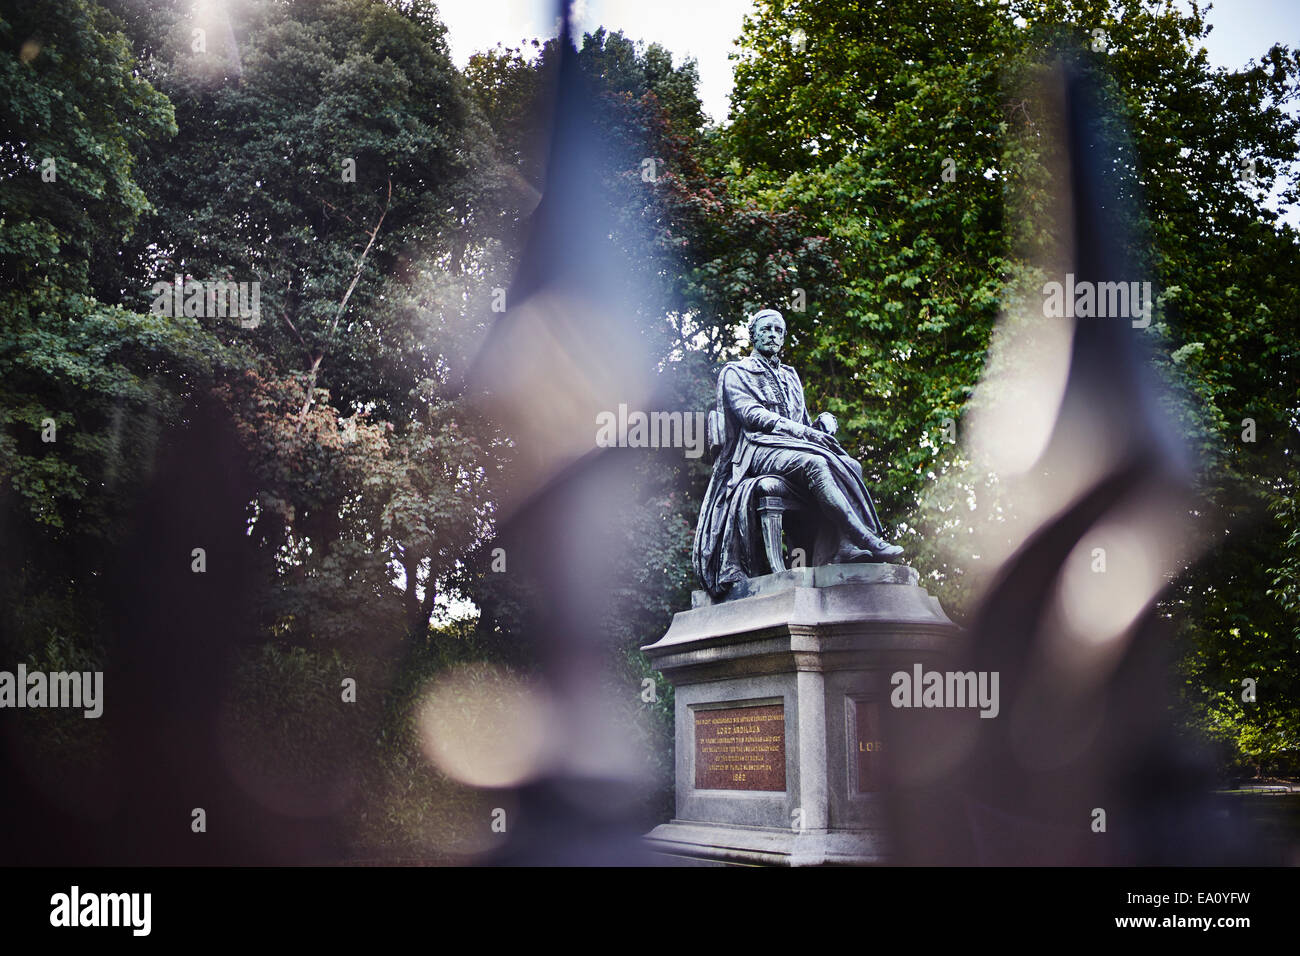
98;0;511;641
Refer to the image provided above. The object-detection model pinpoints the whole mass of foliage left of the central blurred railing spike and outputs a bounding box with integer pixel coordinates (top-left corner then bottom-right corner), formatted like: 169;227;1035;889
0;0;515;853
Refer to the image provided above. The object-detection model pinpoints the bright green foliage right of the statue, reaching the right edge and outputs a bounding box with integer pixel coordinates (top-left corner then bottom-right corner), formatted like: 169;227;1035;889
719;0;1300;770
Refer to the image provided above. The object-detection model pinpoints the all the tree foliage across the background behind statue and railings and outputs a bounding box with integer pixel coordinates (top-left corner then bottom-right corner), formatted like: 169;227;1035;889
0;0;1300;860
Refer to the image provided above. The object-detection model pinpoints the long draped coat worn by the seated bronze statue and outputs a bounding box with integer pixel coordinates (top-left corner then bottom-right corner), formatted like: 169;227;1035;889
692;355;881;597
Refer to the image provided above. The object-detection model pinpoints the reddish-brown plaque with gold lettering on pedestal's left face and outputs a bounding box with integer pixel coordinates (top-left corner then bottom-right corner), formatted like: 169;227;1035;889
696;704;785;790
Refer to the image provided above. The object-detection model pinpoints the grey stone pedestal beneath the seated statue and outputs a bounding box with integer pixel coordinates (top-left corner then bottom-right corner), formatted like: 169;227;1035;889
644;564;959;866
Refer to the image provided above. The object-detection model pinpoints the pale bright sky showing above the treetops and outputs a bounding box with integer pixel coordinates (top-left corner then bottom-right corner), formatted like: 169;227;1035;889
438;0;1300;122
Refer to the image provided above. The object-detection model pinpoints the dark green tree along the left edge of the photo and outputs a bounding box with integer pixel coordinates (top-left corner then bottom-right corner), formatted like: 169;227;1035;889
0;0;231;654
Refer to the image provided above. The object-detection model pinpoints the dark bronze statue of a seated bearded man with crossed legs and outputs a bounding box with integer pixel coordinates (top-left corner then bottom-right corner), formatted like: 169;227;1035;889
692;308;902;598
